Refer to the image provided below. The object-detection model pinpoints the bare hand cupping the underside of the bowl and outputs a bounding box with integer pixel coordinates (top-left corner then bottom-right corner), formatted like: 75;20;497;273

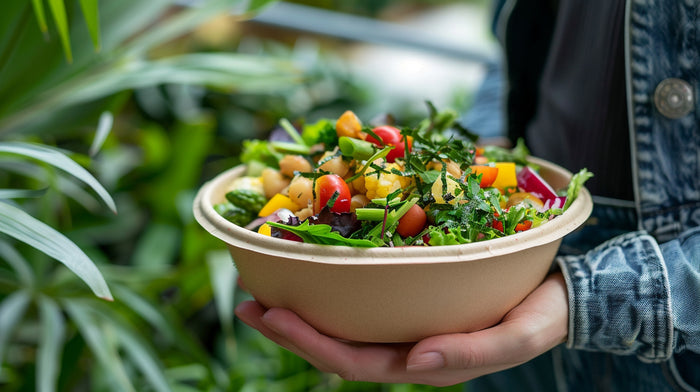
236;273;568;386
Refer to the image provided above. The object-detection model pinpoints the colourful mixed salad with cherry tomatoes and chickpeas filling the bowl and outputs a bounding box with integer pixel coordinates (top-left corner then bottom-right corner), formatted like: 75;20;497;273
215;105;592;247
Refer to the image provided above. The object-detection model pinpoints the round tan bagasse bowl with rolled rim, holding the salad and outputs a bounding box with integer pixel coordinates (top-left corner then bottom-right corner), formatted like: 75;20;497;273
194;158;593;343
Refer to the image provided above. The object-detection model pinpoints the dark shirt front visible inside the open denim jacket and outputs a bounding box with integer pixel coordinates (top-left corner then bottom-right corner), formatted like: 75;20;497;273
525;0;634;200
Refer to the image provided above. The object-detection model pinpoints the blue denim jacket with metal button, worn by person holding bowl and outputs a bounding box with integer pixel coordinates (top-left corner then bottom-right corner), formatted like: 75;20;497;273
464;0;700;390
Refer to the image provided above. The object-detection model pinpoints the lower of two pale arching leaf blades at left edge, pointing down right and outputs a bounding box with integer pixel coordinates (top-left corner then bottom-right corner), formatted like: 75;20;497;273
0;201;112;300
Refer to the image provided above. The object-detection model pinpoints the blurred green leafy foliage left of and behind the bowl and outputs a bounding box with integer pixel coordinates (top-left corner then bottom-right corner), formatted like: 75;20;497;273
0;0;492;392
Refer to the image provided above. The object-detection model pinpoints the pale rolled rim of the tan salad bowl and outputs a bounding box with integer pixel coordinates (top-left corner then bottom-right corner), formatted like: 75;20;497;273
193;157;593;265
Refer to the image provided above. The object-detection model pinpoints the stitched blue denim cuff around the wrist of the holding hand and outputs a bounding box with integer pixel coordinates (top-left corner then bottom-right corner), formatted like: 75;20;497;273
556;232;673;362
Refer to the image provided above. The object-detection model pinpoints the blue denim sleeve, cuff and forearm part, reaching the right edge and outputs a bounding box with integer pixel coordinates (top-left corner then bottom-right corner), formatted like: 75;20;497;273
557;228;700;362
